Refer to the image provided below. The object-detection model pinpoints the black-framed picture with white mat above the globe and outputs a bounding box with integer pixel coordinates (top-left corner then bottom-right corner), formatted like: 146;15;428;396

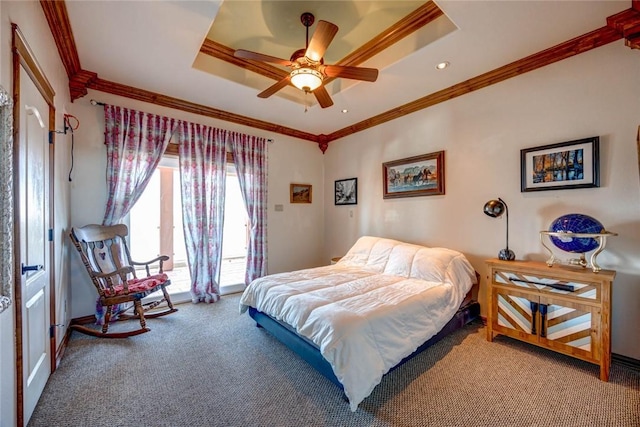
520;136;600;192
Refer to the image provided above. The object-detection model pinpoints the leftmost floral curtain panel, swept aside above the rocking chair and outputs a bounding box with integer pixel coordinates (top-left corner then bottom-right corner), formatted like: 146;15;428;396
102;105;178;225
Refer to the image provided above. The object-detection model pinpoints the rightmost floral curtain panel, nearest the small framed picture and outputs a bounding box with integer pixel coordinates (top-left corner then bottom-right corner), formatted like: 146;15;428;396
228;132;267;285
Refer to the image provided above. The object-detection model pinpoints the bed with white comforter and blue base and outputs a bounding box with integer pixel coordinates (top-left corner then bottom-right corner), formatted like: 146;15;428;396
240;236;480;411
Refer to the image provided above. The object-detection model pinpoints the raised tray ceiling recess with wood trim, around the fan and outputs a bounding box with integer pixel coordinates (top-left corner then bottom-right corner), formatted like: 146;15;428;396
193;0;457;107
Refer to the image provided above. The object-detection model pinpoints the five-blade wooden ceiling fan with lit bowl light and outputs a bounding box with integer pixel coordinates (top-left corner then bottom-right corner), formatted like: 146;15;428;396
234;12;378;108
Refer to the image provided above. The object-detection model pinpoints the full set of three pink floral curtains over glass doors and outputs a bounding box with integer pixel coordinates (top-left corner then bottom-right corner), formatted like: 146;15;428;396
103;105;267;303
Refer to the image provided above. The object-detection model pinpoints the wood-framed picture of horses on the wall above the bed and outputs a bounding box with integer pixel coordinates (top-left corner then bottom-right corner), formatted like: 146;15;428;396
382;151;444;199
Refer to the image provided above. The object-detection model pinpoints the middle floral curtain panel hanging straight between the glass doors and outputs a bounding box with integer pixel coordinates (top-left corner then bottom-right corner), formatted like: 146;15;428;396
178;122;226;303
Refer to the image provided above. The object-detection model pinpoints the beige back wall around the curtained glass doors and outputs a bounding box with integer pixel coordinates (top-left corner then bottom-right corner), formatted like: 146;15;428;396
71;91;324;317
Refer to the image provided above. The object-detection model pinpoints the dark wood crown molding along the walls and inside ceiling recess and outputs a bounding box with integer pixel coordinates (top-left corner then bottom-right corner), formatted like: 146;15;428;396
40;0;640;153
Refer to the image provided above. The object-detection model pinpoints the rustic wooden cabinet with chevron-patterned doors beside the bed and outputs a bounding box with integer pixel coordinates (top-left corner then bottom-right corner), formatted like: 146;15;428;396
486;259;616;381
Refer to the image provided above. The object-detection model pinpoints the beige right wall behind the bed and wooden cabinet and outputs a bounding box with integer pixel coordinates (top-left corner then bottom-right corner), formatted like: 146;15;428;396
325;41;640;359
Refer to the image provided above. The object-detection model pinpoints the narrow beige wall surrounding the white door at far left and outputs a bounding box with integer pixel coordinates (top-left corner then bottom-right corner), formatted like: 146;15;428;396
0;1;71;426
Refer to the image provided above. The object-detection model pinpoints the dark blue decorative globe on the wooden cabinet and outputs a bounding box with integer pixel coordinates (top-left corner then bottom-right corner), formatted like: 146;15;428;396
549;214;605;253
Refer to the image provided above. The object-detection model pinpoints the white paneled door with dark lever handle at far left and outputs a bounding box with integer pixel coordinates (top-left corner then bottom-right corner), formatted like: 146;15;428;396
18;67;51;424
